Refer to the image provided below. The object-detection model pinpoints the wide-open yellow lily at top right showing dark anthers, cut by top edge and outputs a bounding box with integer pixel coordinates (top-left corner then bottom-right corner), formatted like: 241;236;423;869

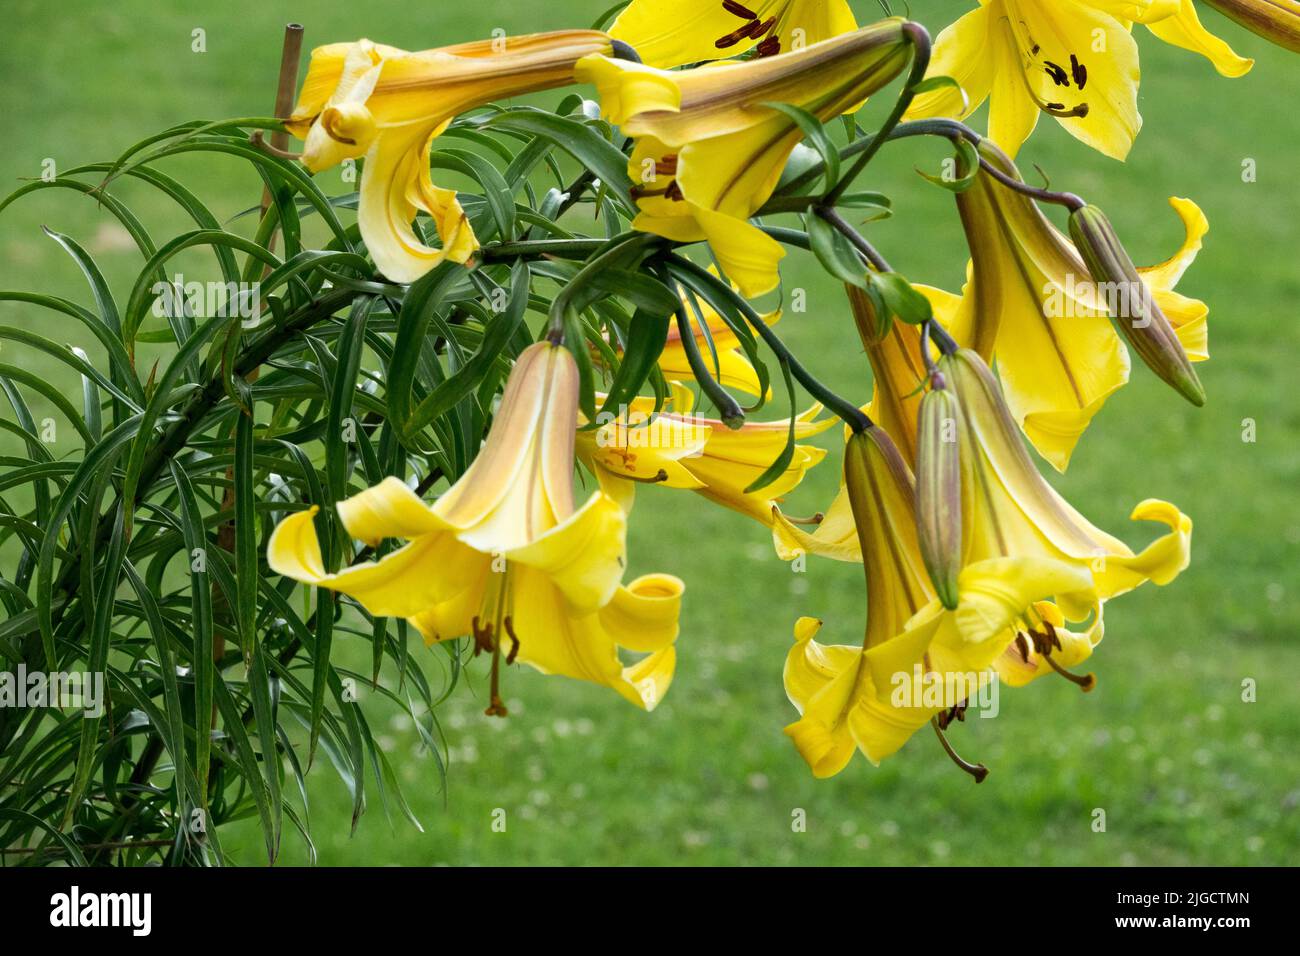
906;0;1255;160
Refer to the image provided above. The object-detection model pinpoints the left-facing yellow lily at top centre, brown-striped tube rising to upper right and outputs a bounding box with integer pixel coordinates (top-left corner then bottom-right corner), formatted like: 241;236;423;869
577;18;910;298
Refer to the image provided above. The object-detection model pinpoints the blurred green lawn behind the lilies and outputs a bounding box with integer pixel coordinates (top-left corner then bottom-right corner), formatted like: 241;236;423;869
0;0;1300;865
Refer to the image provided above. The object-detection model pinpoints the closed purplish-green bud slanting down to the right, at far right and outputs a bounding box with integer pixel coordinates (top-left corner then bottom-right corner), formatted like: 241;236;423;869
1070;206;1205;406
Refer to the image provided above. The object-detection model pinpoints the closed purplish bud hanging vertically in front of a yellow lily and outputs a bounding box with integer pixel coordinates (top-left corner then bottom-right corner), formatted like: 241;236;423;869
917;372;962;610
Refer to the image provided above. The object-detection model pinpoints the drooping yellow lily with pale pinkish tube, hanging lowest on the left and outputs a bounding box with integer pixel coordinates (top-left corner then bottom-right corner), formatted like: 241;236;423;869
267;342;683;715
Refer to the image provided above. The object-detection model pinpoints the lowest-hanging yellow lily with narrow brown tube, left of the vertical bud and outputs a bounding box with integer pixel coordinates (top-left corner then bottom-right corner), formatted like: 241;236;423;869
784;427;1088;779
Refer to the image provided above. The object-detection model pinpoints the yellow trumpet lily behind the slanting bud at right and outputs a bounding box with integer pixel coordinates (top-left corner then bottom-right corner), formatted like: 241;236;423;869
918;140;1209;471
